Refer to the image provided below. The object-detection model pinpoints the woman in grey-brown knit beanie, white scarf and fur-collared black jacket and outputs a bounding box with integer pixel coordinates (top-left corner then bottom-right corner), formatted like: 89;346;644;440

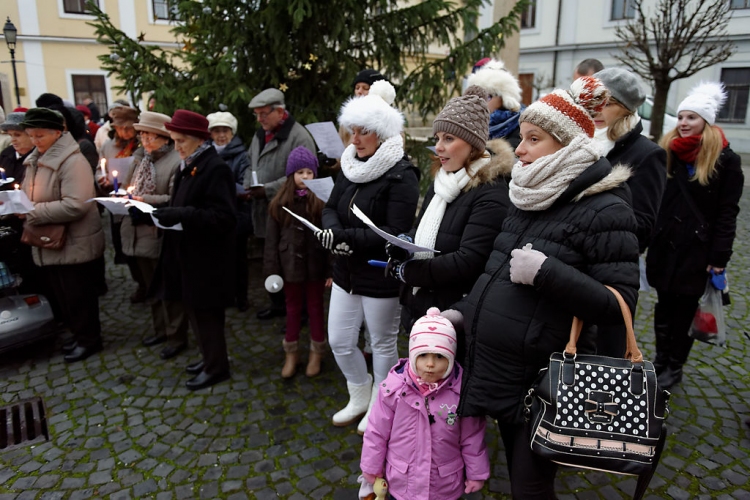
386;87;515;340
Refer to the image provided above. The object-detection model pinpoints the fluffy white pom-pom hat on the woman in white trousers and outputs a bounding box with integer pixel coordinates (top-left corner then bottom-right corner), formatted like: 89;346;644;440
339;80;404;140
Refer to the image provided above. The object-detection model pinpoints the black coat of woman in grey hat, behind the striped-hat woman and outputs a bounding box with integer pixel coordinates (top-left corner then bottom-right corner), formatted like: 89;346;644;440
607;121;667;253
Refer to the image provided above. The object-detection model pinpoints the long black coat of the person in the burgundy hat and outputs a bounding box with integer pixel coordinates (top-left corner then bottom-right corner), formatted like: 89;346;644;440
154;147;237;309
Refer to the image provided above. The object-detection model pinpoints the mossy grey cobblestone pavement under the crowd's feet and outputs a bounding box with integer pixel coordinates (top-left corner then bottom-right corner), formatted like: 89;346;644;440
0;170;750;500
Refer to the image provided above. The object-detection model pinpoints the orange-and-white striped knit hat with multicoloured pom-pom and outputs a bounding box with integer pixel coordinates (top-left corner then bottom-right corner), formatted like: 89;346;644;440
519;76;609;146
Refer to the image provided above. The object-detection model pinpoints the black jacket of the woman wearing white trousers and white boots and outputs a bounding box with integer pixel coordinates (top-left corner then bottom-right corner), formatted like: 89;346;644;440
323;156;419;298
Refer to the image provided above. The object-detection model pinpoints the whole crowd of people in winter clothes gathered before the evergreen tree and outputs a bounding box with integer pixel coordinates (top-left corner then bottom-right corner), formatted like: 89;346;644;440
0;60;743;500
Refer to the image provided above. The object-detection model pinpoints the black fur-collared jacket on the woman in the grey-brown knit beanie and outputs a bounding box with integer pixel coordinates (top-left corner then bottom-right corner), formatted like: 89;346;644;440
401;139;515;332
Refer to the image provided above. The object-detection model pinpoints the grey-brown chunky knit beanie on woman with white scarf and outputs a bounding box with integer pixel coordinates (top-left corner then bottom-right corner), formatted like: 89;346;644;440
432;87;490;151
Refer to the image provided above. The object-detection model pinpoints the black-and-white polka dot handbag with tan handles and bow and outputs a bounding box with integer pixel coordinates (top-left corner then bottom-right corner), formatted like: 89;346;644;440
525;286;669;498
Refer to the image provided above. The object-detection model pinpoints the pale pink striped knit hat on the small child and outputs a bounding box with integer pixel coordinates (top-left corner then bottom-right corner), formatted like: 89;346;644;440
409;307;458;378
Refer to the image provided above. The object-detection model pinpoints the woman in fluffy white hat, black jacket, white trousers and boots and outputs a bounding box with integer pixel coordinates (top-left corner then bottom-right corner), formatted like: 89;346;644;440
317;80;419;433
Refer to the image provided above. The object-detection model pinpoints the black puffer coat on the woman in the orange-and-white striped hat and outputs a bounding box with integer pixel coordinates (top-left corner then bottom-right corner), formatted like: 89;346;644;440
456;158;639;424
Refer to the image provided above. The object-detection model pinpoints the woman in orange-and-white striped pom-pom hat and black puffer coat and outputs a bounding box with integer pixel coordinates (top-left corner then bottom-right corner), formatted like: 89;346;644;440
444;77;638;500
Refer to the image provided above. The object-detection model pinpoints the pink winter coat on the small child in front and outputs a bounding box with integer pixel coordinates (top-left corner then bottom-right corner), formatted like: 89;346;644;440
360;359;490;500
